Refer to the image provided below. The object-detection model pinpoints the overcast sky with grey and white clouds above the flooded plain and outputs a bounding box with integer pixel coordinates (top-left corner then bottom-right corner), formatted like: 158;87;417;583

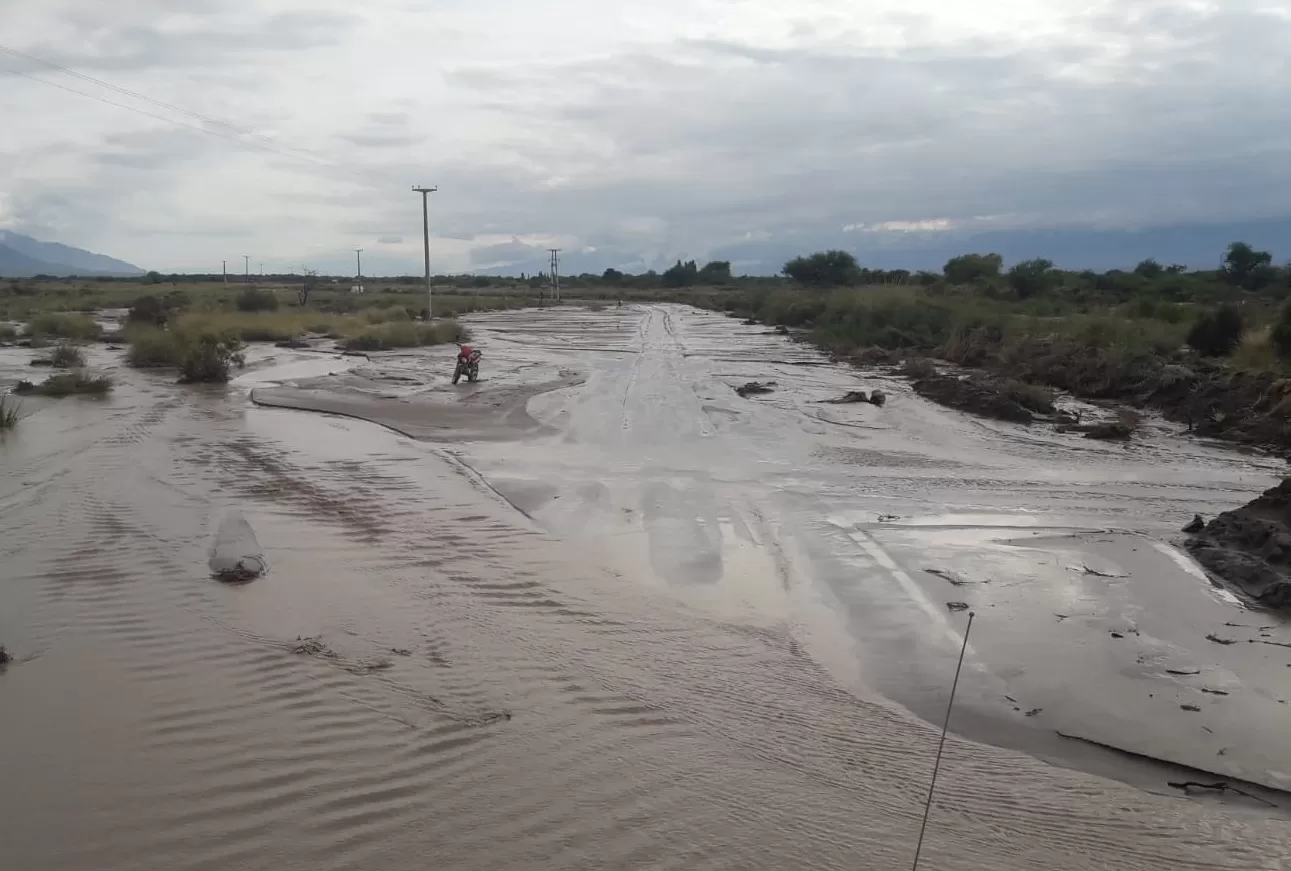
0;0;1291;271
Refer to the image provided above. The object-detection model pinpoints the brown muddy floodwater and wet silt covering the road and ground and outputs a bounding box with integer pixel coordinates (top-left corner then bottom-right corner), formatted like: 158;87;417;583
0;306;1291;871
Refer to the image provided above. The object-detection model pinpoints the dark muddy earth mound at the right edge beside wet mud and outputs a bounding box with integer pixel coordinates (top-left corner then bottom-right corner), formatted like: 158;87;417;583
1186;479;1291;609
